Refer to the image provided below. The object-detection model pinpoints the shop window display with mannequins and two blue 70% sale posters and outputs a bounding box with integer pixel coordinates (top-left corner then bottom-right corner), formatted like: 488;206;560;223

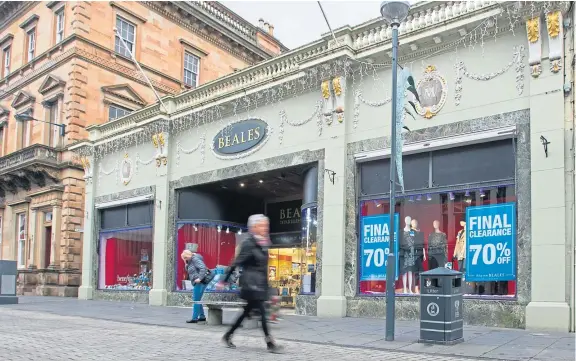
359;185;516;298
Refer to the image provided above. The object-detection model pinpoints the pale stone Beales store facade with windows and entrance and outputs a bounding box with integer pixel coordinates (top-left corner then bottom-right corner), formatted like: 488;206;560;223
74;1;574;330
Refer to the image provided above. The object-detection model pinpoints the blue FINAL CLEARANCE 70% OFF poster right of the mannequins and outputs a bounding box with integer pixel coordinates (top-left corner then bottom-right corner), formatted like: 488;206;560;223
466;203;516;282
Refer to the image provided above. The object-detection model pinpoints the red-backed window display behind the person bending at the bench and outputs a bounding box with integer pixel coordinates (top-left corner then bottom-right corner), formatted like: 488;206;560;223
175;222;247;292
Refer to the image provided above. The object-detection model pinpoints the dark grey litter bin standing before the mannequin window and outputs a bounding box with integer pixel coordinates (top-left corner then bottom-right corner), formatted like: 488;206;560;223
418;267;464;345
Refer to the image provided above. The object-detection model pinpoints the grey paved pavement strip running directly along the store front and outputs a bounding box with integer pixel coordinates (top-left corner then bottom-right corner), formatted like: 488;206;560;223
0;297;576;361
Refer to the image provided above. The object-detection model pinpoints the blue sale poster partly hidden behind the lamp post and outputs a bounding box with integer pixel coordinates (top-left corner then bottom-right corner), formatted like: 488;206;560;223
360;213;400;281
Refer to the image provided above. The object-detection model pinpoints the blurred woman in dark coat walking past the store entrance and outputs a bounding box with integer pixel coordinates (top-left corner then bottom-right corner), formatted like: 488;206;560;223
218;214;282;353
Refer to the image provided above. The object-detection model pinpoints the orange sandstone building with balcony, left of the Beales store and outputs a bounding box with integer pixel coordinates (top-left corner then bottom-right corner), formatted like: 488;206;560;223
0;1;287;296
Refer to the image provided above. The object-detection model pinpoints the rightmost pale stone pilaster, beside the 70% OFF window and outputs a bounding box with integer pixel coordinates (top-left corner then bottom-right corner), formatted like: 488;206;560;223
526;52;574;332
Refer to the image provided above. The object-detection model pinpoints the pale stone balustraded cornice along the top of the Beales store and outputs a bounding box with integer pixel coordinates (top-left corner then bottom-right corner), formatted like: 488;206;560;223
71;1;560;146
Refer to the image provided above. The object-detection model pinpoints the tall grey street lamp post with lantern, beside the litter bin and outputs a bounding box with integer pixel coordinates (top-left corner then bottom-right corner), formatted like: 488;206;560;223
380;1;410;341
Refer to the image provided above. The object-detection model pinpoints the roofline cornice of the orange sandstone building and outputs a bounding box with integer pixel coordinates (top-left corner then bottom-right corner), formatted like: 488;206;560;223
142;1;260;64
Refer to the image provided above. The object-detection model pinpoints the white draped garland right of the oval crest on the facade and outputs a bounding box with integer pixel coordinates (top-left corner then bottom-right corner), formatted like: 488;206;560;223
454;45;525;105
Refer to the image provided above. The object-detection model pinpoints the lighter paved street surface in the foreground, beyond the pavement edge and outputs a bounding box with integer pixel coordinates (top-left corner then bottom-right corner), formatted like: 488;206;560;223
0;307;520;361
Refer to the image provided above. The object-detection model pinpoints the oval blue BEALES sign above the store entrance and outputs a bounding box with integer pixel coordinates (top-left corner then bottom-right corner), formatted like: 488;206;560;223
212;118;270;158
